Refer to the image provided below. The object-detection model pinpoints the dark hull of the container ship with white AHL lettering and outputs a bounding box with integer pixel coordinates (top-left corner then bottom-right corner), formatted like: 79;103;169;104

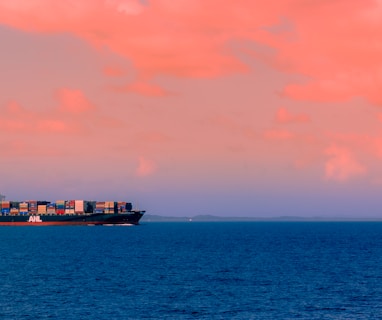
0;211;144;226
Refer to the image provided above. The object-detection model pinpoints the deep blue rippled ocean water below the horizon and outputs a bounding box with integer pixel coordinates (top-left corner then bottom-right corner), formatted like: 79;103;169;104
0;222;382;320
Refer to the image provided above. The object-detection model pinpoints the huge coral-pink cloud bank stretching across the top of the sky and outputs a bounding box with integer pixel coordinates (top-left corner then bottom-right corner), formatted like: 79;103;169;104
0;0;382;104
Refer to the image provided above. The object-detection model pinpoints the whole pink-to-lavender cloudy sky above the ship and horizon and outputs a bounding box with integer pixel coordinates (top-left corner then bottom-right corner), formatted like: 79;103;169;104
0;0;382;218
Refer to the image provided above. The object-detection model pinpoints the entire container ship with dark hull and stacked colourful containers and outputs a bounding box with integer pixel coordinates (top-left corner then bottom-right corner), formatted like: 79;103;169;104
0;195;145;226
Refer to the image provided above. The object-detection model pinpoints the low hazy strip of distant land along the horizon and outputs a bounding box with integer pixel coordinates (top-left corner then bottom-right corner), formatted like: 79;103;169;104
140;214;382;222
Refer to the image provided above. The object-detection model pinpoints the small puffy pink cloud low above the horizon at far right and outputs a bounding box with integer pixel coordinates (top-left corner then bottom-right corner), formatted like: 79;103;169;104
325;146;367;181
